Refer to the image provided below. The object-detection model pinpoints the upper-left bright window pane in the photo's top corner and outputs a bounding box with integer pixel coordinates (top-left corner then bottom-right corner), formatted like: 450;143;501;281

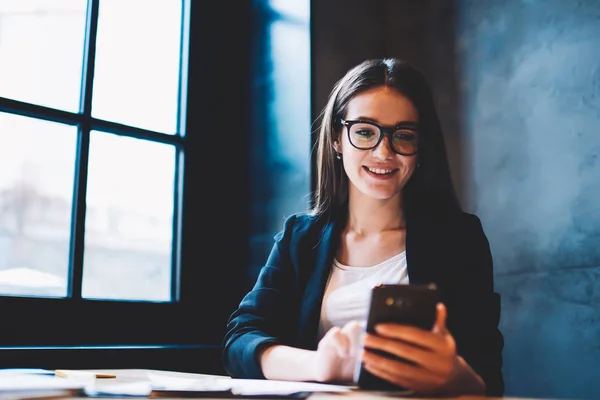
0;0;87;111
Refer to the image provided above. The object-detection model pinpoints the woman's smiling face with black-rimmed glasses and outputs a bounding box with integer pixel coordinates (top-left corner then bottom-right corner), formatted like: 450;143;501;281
333;86;419;203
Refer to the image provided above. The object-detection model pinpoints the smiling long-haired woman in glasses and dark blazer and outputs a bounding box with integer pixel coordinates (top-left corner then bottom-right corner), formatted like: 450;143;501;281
223;59;504;396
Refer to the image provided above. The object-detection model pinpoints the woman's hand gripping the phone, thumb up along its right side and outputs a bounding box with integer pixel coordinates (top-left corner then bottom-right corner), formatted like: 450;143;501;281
362;303;485;395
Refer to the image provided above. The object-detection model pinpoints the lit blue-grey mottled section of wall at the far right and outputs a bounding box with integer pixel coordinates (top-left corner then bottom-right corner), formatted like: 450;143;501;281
456;0;600;398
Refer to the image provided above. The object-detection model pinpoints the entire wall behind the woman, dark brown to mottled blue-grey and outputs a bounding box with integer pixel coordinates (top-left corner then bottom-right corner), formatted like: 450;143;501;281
311;0;600;399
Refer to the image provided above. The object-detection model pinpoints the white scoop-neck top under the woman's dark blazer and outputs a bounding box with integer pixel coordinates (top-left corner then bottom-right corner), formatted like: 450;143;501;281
318;251;408;340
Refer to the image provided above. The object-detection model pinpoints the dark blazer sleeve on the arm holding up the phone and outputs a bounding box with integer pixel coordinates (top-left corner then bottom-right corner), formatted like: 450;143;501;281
448;215;504;397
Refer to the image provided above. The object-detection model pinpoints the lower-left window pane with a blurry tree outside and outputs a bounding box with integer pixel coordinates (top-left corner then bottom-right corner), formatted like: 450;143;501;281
0;113;77;297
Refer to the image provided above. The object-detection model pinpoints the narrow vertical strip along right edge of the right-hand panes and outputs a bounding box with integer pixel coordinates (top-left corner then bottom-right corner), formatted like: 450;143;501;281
171;0;190;301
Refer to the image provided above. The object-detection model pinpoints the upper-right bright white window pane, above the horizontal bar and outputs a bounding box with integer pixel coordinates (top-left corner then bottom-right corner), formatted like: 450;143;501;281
92;0;182;133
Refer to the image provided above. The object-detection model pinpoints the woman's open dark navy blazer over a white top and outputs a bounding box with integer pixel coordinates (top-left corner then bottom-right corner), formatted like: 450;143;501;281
223;208;504;396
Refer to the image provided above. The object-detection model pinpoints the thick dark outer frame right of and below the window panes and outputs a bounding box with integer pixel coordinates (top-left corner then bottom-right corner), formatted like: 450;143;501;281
0;0;255;373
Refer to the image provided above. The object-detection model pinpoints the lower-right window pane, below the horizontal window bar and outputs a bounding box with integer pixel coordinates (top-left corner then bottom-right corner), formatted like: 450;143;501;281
82;132;175;301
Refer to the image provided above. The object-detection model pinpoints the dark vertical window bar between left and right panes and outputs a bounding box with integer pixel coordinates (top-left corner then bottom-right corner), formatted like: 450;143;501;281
68;0;99;299
